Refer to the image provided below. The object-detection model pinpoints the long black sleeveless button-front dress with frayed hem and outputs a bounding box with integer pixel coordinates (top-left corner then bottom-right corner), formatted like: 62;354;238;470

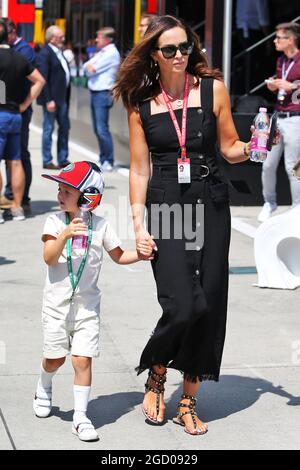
136;78;230;382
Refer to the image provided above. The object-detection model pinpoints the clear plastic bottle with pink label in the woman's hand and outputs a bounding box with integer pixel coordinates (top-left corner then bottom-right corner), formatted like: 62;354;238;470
250;108;270;162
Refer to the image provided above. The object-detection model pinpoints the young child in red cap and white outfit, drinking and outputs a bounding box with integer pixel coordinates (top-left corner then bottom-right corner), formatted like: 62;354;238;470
33;161;152;441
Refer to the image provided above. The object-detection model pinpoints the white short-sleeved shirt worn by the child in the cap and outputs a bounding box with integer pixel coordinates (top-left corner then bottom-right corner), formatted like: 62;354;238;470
43;212;121;319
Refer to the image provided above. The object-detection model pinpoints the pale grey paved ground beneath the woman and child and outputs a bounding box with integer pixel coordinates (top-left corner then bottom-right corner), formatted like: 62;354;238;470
0;132;300;450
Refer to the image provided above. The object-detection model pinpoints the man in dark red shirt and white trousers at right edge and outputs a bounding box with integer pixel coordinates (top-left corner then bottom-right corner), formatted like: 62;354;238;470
258;23;300;222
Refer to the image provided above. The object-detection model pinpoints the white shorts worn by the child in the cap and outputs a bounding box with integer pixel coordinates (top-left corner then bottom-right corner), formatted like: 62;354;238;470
42;313;100;359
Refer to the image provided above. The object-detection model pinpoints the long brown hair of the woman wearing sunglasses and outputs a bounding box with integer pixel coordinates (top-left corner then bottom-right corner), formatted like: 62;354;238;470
114;15;223;109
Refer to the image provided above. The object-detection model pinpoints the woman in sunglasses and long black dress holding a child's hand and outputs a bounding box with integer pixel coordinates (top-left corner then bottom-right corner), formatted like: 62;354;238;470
115;16;250;435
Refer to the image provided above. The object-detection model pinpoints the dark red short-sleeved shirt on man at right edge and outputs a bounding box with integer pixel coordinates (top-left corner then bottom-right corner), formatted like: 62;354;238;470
276;51;300;112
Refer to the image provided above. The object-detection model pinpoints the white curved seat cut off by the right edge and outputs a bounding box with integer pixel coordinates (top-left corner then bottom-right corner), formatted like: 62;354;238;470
254;205;300;289
